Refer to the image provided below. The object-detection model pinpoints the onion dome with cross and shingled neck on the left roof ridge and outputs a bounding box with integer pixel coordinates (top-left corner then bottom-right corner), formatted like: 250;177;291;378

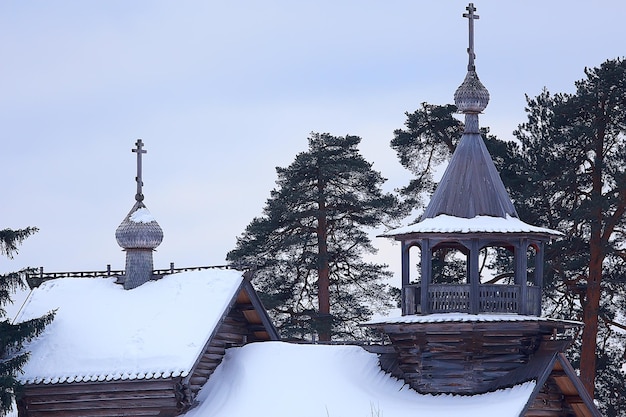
115;139;163;290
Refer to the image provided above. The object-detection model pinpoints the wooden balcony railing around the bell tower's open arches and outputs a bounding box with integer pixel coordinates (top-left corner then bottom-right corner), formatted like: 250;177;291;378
402;284;541;316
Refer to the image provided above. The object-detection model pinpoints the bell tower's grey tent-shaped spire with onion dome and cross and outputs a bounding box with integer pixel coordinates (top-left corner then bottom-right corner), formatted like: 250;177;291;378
422;3;518;220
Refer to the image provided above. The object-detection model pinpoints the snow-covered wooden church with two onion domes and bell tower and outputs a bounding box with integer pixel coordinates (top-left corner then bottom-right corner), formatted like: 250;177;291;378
12;3;600;417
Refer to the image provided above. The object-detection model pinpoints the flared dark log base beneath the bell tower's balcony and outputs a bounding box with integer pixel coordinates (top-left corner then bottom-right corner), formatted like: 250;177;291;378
368;319;576;394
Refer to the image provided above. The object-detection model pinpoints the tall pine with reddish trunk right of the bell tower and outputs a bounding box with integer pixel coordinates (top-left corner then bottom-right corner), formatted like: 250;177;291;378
515;59;626;402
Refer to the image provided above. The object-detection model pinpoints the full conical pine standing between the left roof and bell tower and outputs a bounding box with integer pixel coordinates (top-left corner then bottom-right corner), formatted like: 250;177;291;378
227;133;401;340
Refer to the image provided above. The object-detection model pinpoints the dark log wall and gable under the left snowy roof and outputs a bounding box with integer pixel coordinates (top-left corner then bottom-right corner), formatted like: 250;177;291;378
18;280;278;417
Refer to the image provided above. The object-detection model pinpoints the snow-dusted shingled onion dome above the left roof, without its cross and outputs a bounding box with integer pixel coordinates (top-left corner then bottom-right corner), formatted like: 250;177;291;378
115;201;163;249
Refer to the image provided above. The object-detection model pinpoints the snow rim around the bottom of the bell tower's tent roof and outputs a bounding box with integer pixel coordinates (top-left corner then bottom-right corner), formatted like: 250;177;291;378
383;214;563;236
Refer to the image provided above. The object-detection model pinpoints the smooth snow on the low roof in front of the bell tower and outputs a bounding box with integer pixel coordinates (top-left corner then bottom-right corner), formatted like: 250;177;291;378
184;342;535;417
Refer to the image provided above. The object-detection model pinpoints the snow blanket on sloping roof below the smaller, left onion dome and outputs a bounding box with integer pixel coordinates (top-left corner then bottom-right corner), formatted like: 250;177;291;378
17;269;242;383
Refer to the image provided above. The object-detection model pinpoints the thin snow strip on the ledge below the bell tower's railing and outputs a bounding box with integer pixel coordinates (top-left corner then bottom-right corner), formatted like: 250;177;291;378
365;313;582;326
